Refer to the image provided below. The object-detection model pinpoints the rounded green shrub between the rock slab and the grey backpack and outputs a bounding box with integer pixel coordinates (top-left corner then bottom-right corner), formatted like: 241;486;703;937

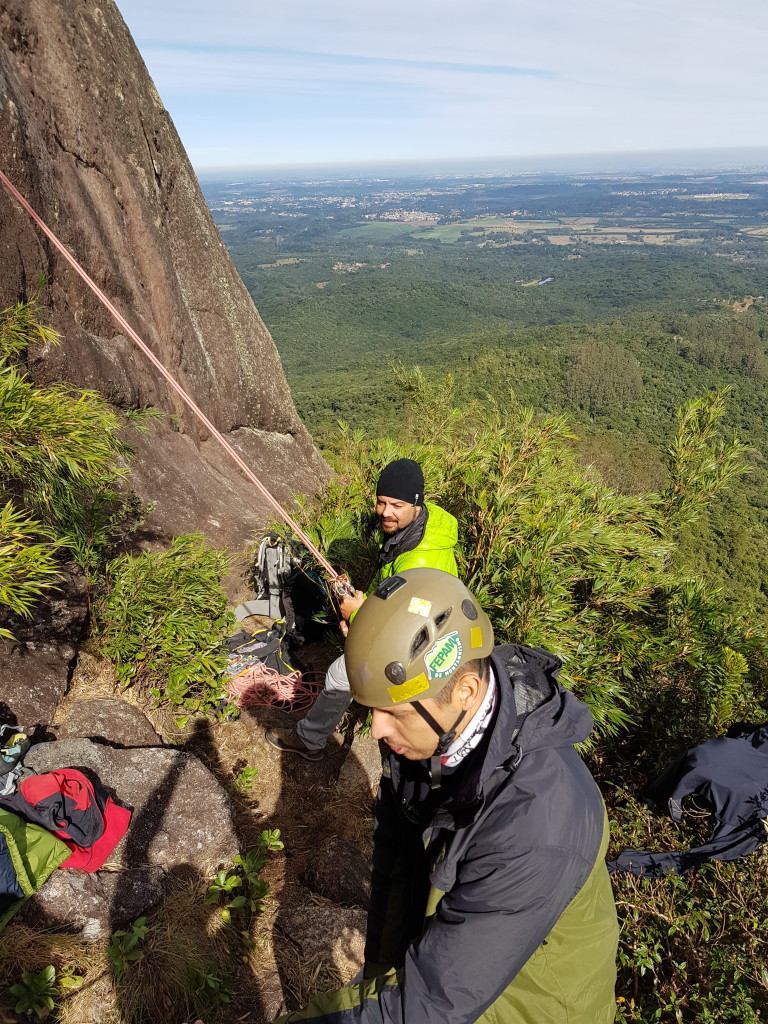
96;535;234;712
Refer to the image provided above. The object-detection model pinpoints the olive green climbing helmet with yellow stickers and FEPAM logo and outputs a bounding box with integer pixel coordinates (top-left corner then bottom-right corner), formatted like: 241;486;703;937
344;568;494;708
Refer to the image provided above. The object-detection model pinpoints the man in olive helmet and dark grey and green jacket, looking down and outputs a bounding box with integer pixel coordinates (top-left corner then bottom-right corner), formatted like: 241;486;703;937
284;568;617;1024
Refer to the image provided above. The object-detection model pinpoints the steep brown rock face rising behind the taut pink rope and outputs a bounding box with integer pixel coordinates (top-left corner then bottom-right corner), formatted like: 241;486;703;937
0;0;328;544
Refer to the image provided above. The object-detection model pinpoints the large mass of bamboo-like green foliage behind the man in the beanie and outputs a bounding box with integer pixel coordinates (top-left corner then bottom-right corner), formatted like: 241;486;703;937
288;370;768;746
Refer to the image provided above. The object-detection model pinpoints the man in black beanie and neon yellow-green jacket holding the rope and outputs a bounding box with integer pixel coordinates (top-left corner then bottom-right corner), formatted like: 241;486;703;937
266;459;459;761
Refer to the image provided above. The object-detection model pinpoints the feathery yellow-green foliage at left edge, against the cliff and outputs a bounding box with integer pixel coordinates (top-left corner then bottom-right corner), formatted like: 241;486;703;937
0;282;142;638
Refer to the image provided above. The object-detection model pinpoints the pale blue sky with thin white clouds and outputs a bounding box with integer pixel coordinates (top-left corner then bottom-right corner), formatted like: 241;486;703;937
117;0;768;170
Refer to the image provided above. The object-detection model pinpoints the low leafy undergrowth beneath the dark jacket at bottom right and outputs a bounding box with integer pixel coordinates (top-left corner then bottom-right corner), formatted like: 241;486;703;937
611;794;768;1024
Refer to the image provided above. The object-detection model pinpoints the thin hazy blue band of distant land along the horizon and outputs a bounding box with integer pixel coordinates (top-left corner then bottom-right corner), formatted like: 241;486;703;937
195;146;768;177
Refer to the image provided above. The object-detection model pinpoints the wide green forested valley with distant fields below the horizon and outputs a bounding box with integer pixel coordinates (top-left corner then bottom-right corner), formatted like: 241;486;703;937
203;172;768;616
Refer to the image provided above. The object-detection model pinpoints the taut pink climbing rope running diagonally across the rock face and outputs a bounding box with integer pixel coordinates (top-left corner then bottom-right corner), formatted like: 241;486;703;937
0;164;354;597
